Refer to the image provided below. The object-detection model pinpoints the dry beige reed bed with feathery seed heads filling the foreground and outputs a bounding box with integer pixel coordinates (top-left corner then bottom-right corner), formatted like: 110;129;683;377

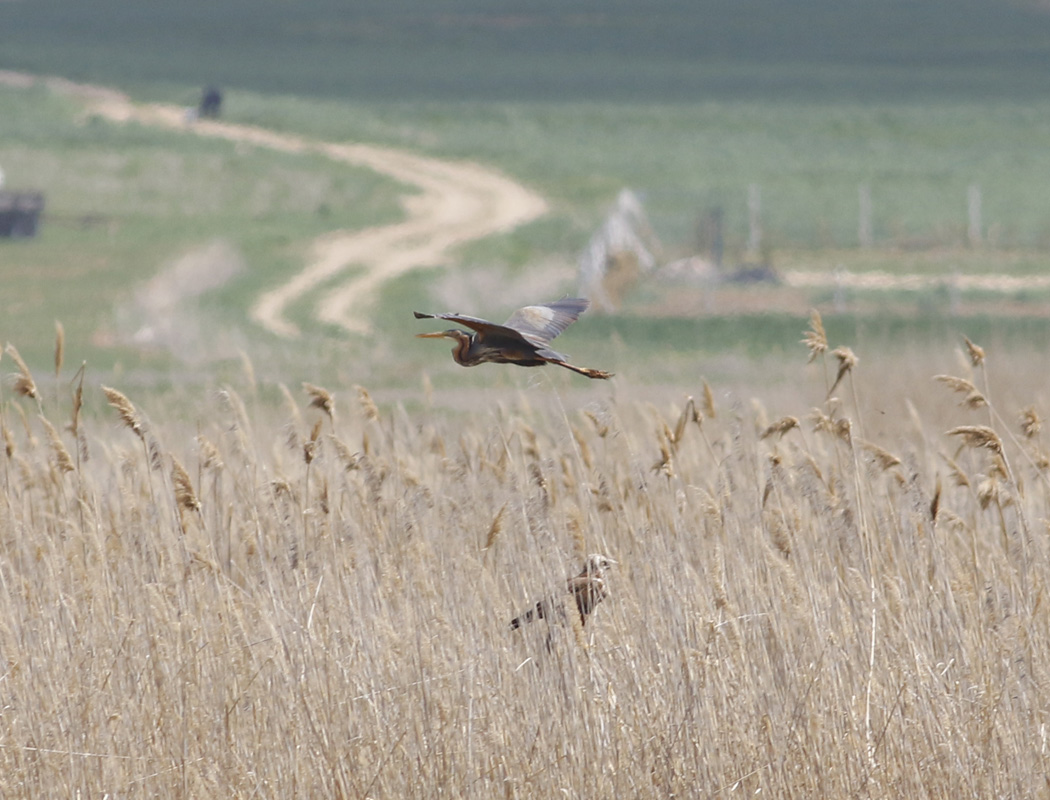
0;317;1050;798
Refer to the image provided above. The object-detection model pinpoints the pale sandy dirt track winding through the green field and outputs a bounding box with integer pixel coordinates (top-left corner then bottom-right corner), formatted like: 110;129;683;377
6;72;547;337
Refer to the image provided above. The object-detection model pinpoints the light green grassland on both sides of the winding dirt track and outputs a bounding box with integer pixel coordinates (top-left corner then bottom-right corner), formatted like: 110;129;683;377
10;79;1050;383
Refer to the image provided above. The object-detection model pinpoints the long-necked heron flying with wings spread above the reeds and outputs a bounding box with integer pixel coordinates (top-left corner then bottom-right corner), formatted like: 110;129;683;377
415;297;612;378
